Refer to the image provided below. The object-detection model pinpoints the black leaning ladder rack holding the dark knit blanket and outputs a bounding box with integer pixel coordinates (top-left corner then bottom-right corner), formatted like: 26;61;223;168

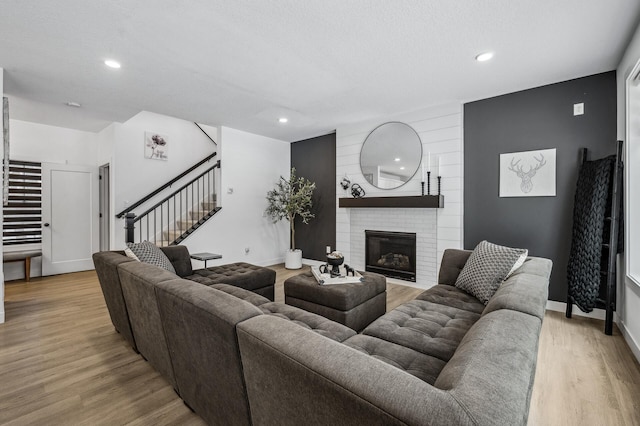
566;141;623;335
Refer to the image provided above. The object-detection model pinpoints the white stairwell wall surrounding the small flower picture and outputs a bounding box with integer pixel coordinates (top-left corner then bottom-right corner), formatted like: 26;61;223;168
109;111;220;249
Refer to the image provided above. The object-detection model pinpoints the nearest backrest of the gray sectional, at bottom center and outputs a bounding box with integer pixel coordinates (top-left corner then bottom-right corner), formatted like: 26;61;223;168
238;315;473;425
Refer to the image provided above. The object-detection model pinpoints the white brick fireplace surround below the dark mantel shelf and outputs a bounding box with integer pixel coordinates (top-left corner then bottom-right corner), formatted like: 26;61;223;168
349;208;437;288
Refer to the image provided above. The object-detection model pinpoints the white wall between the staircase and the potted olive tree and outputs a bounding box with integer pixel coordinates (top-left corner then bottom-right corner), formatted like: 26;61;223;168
182;127;291;268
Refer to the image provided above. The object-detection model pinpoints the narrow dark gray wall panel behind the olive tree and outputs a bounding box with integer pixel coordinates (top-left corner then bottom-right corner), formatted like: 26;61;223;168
291;133;336;261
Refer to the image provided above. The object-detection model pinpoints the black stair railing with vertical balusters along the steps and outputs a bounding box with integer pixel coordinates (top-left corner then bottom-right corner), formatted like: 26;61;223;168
122;159;220;246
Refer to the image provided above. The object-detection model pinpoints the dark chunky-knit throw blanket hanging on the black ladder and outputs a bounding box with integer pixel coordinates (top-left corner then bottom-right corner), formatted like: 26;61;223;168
567;156;616;312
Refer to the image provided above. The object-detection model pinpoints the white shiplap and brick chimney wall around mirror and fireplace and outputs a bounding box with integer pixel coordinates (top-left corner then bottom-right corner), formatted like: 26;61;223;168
336;104;463;288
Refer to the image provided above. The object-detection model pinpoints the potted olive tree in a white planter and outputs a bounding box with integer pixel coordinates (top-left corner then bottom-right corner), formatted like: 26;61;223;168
265;167;316;269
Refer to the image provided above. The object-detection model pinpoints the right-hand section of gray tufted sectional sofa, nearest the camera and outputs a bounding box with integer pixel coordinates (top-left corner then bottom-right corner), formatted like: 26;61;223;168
238;250;551;425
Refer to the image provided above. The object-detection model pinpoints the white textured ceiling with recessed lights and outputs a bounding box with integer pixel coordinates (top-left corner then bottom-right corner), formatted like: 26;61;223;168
0;0;640;141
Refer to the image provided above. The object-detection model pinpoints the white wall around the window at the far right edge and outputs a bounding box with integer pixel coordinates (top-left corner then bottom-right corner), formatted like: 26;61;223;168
617;22;640;361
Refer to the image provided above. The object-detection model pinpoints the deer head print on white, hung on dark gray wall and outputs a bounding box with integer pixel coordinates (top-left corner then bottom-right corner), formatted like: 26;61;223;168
500;149;556;197
